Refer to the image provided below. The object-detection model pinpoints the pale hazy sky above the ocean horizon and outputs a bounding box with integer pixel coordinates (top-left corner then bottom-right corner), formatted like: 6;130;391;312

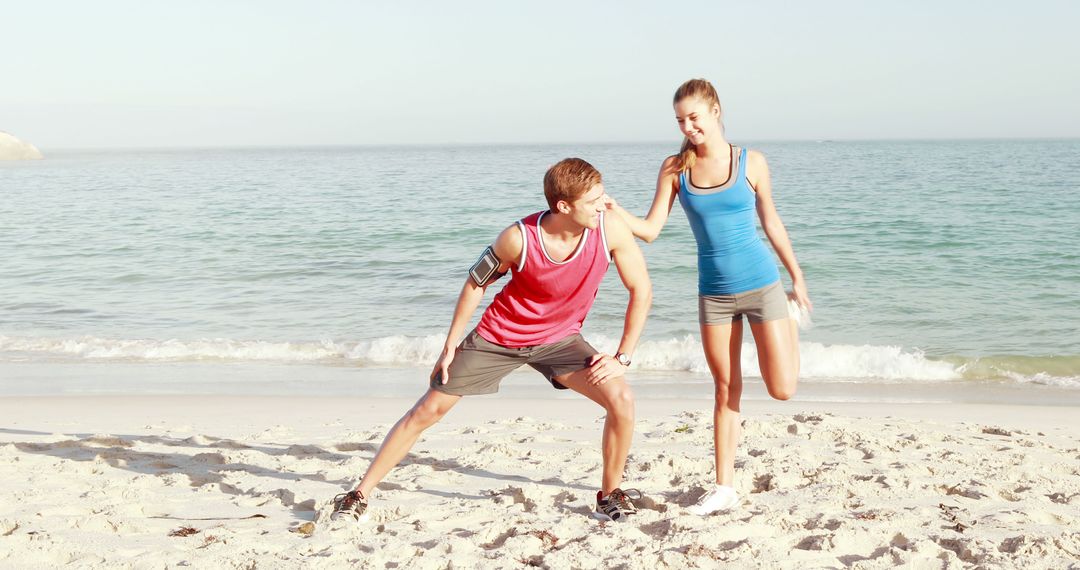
0;0;1080;150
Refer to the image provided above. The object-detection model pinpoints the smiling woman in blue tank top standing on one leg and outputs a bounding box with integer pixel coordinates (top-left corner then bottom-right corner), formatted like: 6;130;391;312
608;79;812;515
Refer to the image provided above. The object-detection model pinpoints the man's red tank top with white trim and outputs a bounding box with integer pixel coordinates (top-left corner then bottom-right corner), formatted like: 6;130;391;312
476;212;611;348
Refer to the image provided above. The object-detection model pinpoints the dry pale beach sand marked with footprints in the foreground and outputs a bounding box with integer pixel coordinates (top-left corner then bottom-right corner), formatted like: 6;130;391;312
0;396;1080;569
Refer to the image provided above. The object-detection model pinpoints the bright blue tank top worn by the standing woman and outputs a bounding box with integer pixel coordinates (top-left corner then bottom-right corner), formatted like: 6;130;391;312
678;144;780;295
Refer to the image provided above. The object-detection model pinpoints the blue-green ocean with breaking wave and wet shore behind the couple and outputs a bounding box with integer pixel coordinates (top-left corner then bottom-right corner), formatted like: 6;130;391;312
0;140;1080;403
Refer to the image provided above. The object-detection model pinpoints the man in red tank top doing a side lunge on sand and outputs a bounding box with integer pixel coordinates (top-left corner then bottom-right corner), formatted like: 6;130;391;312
332;159;652;520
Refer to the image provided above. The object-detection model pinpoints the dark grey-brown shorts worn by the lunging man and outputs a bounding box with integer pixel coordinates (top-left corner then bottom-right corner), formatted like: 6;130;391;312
431;330;599;396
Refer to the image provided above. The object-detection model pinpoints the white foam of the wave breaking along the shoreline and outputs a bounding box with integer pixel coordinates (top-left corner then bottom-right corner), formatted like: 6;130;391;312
0;335;1080;389
